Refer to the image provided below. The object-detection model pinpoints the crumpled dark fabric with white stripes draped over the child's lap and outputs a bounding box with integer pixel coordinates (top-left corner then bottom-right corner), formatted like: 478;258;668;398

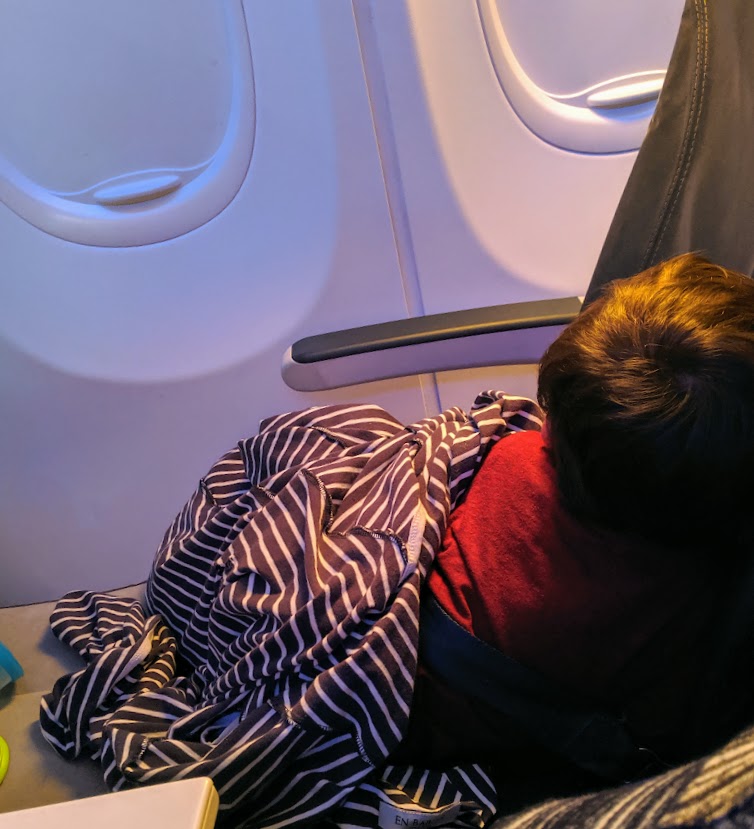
40;392;541;827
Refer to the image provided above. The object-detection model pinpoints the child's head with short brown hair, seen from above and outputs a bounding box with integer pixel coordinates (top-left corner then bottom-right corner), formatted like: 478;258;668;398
539;254;754;552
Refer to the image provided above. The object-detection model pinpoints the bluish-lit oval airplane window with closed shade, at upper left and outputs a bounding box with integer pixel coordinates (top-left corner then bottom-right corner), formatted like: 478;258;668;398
0;0;254;246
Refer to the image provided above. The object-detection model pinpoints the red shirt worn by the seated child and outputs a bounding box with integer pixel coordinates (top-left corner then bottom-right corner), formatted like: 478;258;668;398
396;432;709;759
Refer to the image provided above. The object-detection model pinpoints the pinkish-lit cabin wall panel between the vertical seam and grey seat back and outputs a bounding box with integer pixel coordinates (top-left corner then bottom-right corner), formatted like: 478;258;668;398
362;0;683;407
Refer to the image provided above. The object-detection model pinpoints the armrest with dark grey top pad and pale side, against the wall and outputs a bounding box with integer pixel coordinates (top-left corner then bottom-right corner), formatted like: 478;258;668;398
282;297;582;391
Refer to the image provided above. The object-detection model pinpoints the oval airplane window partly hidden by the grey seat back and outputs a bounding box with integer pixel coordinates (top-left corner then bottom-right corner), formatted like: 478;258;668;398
478;0;683;153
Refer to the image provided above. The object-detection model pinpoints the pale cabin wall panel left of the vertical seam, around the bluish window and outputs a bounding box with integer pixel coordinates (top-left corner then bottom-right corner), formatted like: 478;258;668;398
0;0;426;604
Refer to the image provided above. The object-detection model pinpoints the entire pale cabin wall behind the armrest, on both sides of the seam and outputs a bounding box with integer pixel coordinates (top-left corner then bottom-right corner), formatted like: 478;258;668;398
0;0;682;604
